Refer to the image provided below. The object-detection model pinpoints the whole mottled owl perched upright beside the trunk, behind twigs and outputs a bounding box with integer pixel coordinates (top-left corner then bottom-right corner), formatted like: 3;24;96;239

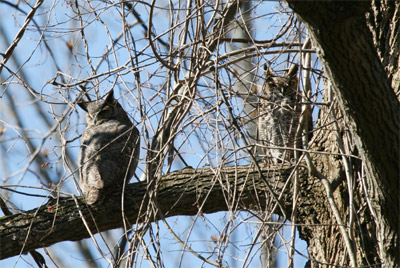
258;65;299;164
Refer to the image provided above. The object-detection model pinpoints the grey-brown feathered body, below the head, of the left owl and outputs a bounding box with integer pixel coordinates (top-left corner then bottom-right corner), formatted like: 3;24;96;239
79;122;140;204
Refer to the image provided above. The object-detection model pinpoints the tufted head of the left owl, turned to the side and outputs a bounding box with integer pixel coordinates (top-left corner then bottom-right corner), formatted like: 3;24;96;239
78;89;131;126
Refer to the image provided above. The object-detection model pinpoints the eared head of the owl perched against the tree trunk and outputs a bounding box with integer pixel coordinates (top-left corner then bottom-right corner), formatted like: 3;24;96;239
263;64;299;96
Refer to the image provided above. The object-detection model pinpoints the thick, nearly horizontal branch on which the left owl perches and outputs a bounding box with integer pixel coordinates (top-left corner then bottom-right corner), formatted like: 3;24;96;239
0;166;306;259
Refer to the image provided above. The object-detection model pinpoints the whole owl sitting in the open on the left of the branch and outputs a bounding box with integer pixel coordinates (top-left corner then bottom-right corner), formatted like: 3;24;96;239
78;90;140;204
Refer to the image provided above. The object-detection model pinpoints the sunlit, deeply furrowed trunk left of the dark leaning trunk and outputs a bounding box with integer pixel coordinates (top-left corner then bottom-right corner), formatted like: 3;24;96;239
299;88;381;267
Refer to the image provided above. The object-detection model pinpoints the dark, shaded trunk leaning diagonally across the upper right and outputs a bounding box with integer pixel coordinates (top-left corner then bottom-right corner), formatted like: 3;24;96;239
288;0;400;267
